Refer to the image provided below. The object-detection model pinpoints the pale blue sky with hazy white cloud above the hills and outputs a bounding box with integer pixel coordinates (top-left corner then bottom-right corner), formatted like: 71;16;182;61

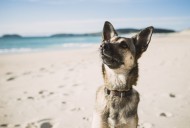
0;0;190;36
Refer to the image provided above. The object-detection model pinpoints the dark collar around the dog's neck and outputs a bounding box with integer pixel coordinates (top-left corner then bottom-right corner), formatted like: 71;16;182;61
104;87;133;98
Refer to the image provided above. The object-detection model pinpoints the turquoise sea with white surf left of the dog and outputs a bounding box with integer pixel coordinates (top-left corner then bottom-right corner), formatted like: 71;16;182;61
0;36;101;54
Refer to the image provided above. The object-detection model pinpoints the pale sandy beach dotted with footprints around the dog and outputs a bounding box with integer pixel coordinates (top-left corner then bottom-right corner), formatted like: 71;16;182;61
0;31;190;128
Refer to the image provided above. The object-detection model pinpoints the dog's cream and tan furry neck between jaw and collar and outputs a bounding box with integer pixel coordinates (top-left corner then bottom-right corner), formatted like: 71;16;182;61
102;65;138;91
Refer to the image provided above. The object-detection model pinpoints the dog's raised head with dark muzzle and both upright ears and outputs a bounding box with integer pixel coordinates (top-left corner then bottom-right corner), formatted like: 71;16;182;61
100;21;153;70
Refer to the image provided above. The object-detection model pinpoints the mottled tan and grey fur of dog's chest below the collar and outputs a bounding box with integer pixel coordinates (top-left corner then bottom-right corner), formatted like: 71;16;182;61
104;90;139;128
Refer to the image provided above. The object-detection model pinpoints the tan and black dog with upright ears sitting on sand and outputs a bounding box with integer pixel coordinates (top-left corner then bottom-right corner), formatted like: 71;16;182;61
92;21;153;128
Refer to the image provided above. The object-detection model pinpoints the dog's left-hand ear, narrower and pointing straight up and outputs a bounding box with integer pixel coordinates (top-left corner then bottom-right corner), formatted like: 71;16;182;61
102;21;118;41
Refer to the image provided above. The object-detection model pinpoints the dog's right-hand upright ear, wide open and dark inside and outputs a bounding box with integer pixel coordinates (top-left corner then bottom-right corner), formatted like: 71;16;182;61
132;26;154;58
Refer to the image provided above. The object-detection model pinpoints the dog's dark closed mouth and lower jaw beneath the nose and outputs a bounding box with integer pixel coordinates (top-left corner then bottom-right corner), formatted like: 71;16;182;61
101;49;124;69
